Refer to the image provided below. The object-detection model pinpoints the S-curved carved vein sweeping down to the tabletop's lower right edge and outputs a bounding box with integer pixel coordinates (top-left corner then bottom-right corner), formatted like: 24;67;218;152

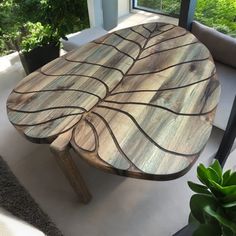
97;105;199;157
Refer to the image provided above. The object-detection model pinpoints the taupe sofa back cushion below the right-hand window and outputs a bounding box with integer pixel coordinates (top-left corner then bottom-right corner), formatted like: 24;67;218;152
191;21;236;68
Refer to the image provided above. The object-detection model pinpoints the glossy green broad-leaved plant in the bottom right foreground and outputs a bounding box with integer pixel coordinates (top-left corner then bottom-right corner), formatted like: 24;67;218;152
188;160;236;236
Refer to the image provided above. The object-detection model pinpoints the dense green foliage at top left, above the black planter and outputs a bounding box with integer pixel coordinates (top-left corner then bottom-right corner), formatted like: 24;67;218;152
0;0;89;55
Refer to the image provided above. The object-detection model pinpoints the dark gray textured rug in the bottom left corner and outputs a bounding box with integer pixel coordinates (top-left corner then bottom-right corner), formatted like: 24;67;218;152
0;156;62;236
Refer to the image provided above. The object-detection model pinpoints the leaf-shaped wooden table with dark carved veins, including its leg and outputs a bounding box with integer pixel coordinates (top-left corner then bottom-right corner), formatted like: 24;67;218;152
7;23;220;202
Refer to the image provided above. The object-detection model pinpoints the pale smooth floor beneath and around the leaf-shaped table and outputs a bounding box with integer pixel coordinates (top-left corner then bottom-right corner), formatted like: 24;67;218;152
0;11;234;236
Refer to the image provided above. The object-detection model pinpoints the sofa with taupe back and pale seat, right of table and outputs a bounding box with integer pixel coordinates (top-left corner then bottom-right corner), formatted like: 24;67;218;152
191;21;236;130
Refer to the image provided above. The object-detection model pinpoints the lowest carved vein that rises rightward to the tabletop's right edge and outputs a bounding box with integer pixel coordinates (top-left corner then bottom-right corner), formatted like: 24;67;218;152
109;70;216;97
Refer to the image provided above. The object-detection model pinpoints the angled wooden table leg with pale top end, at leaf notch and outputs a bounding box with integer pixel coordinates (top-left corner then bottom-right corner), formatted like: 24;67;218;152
50;130;92;204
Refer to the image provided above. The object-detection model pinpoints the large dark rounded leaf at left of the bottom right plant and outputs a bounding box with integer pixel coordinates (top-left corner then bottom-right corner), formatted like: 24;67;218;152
190;194;217;224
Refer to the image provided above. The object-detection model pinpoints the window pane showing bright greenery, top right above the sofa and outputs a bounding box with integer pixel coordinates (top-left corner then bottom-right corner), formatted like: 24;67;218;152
195;0;236;37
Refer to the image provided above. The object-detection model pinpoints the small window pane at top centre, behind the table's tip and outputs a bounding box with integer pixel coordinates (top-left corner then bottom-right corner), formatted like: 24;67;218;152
134;0;181;16
